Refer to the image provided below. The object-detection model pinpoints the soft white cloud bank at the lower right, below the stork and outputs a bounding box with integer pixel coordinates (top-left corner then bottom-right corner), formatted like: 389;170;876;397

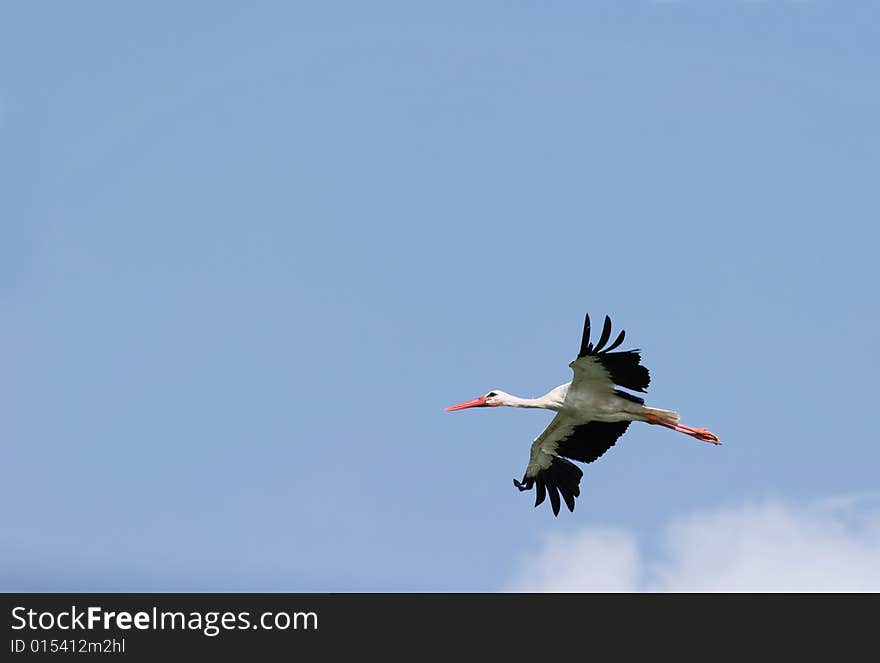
506;498;880;592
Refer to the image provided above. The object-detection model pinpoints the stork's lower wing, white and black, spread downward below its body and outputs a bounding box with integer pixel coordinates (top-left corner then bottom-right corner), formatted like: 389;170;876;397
513;413;629;516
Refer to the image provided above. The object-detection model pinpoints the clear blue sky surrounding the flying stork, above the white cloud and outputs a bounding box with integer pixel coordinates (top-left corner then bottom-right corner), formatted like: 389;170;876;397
0;0;880;591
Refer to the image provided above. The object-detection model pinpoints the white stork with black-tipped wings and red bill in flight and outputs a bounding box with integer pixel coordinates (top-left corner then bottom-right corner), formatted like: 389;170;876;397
446;313;721;516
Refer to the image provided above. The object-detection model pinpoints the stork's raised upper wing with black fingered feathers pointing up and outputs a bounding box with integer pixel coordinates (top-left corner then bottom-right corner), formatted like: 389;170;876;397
569;313;651;398
